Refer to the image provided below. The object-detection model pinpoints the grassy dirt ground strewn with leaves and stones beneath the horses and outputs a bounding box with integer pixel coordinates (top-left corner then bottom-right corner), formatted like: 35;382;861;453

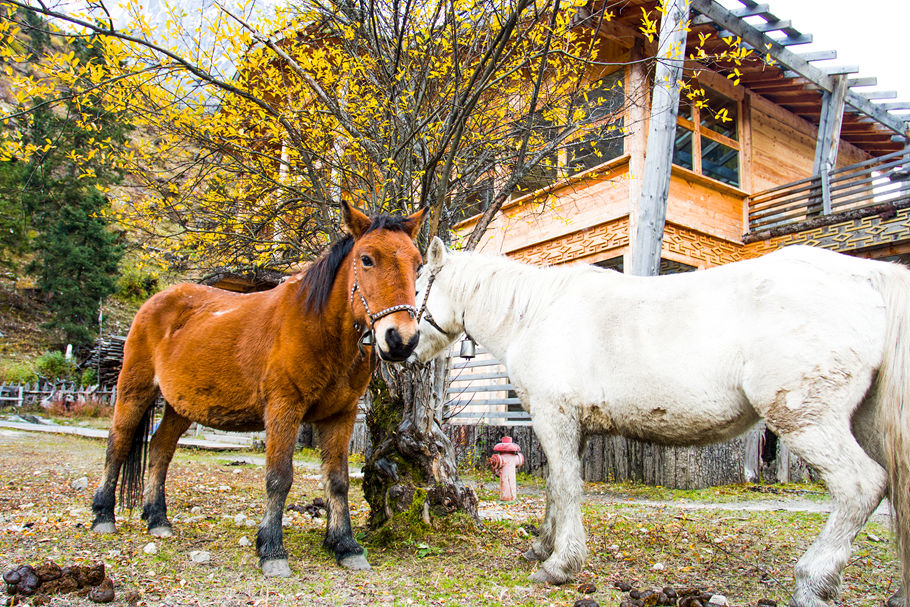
0;429;898;607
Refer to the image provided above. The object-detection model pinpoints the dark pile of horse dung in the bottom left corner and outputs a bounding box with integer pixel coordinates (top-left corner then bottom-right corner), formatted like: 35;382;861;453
0;561;135;605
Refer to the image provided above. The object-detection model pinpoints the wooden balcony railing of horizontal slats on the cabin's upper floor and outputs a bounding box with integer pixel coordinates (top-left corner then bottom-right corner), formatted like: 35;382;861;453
747;150;910;234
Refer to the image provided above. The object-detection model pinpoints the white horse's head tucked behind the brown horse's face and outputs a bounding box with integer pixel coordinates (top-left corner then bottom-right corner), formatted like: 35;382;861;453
416;237;464;363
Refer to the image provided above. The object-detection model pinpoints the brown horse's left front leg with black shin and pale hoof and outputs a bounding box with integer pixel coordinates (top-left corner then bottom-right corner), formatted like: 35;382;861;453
256;405;300;577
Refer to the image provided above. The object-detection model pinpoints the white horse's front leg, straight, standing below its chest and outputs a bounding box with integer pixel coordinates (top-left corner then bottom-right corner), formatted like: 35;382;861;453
531;405;588;584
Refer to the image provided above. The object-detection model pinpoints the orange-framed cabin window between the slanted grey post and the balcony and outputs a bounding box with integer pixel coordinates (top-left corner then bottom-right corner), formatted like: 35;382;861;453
673;85;740;187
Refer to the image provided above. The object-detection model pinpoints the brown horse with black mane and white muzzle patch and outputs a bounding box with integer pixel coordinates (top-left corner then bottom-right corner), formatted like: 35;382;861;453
92;204;426;576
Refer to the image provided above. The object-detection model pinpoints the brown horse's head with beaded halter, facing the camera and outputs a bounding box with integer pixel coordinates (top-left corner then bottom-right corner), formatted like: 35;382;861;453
341;203;427;362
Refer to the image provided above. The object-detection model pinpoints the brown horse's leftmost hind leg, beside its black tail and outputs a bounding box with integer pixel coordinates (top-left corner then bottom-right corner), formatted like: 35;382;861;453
92;378;158;533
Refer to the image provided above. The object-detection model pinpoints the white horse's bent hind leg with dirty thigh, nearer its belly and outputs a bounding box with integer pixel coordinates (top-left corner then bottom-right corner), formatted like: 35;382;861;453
781;418;887;607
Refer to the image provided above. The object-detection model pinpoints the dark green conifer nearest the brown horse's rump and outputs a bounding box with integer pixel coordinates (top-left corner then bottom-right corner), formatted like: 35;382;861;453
6;27;129;345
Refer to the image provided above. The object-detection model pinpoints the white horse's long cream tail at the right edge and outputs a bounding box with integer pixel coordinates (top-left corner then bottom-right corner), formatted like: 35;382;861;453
874;265;910;596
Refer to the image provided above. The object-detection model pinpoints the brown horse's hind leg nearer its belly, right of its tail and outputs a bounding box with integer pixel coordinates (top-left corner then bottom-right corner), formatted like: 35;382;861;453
142;404;190;537
